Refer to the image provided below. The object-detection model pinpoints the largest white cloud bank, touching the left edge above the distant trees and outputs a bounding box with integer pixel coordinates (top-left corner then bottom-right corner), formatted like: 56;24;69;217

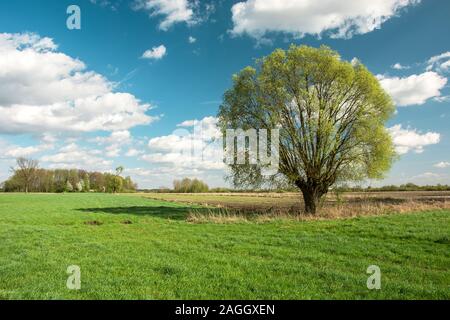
0;33;156;134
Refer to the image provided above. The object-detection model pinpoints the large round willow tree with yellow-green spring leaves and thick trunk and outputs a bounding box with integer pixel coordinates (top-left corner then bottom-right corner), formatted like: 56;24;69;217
219;45;395;213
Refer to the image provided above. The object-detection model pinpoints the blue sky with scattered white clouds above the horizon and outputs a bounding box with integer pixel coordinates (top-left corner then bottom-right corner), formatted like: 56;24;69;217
0;0;450;187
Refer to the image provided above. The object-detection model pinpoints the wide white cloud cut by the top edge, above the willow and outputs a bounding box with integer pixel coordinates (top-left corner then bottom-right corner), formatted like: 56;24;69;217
231;0;420;38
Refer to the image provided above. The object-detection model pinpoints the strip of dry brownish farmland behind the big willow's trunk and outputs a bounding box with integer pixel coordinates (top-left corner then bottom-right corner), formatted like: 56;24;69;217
137;191;450;219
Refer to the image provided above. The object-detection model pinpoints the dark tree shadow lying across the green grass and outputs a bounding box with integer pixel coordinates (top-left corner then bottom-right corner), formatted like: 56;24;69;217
77;206;192;220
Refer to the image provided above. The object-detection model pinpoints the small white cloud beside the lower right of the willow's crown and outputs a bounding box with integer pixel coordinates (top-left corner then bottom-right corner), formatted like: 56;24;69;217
388;124;441;154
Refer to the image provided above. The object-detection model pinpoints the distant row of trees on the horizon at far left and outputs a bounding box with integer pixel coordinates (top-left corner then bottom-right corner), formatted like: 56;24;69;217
1;158;137;193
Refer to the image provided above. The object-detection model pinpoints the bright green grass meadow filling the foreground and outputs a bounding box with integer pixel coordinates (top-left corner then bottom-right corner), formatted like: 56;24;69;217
0;194;450;299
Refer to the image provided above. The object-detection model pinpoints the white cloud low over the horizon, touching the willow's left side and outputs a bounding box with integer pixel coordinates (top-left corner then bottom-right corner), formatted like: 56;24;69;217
130;117;226;187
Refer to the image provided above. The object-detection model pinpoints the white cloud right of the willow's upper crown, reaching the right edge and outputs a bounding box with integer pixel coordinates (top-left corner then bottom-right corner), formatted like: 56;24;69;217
378;71;447;107
